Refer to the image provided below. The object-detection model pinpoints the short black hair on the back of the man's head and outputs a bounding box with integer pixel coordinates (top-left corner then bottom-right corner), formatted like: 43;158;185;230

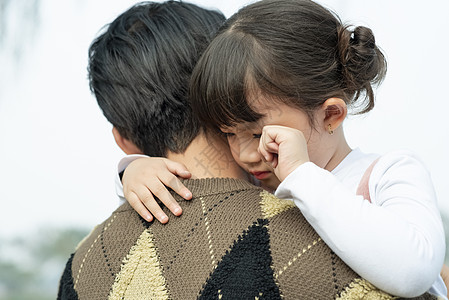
88;1;225;156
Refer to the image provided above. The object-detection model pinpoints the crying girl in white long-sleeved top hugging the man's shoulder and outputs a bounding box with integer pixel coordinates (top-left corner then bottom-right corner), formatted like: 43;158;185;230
118;0;446;297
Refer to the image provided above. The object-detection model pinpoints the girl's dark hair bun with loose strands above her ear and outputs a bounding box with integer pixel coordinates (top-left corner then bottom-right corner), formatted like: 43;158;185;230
338;26;386;113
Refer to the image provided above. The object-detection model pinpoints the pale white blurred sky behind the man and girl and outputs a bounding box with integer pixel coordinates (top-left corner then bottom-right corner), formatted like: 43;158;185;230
0;0;449;237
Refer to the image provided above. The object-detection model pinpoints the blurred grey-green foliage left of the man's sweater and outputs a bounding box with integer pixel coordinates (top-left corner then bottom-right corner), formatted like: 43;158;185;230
0;228;88;300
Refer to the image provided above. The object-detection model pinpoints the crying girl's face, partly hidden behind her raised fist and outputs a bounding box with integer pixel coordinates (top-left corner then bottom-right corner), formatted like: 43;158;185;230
221;98;330;190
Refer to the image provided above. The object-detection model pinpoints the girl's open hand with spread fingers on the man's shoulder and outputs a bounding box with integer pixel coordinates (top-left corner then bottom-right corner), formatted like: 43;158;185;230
122;157;192;223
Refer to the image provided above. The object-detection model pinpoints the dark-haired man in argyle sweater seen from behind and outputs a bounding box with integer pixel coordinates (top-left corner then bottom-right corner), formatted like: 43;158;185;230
58;1;434;299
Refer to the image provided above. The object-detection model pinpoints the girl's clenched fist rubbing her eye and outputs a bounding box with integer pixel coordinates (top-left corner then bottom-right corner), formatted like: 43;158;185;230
258;125;309;181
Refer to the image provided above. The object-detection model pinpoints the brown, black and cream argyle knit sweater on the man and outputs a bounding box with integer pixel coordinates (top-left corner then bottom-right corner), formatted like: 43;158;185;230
58;178;433;300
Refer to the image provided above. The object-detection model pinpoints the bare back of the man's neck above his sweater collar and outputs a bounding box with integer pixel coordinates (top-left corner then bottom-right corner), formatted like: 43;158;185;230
167;133;248;180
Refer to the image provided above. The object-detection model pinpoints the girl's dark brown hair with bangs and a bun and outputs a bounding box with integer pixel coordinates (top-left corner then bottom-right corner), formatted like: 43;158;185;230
191;0;386;127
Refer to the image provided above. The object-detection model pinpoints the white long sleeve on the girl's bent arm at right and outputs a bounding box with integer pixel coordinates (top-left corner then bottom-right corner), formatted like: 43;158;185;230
276;154;445;297
